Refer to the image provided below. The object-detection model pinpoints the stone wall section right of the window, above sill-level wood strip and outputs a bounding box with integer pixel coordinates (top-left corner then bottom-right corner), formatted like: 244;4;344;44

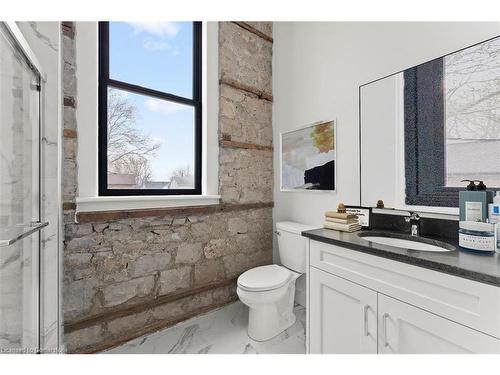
219;22;273;202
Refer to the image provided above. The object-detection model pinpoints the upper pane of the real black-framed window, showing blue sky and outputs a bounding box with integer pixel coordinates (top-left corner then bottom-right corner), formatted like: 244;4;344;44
109;22;193;99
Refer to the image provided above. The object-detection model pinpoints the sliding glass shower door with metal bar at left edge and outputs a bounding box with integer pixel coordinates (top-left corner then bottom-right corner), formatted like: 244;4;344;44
0;24;43;353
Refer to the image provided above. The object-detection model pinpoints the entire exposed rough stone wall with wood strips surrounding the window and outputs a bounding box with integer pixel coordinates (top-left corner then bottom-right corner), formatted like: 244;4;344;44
63;22;273;352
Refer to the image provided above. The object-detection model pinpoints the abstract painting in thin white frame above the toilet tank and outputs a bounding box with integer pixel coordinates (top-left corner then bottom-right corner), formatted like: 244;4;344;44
279;119;337;193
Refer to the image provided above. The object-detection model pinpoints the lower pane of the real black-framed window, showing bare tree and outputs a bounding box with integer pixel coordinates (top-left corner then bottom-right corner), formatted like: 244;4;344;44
108;88;195;189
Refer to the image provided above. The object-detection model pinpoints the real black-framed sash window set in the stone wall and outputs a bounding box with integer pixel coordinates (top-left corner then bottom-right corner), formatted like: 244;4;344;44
99;22;202;195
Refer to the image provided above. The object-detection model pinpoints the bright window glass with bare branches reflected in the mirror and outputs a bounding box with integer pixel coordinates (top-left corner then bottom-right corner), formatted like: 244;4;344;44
445;38;500;187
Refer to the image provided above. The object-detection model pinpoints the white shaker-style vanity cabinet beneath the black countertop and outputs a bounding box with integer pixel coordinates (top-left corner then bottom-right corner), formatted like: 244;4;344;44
307;240;500;354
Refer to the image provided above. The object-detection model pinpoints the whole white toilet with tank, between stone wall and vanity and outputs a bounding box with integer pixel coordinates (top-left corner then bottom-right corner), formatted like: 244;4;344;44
236;221;314;341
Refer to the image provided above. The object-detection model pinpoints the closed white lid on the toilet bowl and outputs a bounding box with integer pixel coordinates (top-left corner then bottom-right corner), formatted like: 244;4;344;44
238;264;291;291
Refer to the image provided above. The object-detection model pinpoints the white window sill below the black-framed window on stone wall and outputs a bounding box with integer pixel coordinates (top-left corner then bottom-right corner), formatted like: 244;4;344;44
76;195;220;212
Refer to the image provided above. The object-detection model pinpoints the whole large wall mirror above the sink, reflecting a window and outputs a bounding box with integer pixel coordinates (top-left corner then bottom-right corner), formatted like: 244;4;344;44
360;38;500;208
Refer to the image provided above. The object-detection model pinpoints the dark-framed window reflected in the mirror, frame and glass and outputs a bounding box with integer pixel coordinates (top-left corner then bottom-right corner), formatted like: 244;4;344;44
404;38;500;207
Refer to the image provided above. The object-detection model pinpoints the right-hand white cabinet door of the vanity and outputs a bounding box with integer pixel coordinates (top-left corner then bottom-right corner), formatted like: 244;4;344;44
378;294;500;354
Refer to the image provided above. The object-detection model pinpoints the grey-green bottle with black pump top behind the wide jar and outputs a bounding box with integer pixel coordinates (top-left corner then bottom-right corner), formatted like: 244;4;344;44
458;180;493;222
